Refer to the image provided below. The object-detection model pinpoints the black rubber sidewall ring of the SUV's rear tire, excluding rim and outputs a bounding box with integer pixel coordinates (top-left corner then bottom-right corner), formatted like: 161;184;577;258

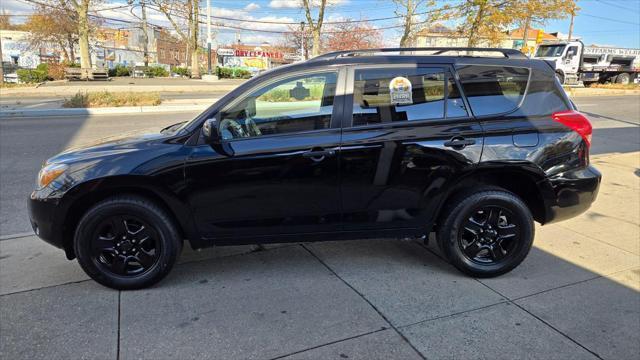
441;191;534;277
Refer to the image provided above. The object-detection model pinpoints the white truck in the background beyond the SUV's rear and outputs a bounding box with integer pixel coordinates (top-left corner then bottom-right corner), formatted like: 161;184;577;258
534;40;640;86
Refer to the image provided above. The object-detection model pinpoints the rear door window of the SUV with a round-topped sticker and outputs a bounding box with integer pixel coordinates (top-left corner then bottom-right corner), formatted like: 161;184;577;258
353;67;467;126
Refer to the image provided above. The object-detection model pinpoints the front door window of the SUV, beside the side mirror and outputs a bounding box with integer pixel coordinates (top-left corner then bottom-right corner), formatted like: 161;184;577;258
220;72;337;140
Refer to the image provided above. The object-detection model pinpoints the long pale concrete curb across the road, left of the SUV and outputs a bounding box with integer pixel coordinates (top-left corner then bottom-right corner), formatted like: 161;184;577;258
0;104;210;119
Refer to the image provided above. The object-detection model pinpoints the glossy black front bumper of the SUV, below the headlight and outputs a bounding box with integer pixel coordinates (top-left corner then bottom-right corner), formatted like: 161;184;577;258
27;191;64;249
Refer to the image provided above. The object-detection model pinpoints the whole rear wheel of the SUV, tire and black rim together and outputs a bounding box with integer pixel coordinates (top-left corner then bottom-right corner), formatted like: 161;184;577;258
437;188;535;278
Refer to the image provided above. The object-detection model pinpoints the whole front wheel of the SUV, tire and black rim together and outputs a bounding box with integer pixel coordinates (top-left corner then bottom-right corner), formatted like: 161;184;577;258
74;196;182;290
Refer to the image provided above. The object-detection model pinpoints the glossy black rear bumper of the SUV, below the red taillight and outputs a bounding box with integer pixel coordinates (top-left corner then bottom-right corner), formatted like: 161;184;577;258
545;166;602;224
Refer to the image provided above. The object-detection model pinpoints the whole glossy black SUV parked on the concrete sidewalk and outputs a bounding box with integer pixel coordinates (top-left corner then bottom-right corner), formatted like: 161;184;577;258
29;48;601;289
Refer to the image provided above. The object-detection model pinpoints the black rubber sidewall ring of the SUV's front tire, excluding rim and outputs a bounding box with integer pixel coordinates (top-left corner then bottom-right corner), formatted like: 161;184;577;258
74;200;180;289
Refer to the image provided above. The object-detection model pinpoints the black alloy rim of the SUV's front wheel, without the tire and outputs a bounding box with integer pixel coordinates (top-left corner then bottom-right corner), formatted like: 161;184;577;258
92;215;161;276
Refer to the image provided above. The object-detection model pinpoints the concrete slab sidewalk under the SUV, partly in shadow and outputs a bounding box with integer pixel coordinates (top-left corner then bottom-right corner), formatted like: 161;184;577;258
0;152;640;359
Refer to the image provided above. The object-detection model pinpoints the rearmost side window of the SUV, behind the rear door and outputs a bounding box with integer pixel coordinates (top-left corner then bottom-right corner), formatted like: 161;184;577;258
457;65;529;116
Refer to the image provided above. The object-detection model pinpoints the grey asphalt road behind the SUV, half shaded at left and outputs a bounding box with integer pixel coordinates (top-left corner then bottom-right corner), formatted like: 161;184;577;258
0;96;640;237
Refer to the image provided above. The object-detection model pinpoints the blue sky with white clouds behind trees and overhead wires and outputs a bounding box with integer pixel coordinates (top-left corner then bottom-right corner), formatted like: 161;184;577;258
0;0;640;48
